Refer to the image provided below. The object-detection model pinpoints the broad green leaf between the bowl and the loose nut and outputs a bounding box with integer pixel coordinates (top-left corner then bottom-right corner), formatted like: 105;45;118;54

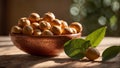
64;39;90;59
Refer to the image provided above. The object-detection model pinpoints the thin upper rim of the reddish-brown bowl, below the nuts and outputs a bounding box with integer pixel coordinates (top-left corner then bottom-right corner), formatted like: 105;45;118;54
9;32;82;38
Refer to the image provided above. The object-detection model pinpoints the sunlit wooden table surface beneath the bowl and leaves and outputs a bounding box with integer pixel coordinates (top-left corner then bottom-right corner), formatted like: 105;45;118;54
0;36;120;68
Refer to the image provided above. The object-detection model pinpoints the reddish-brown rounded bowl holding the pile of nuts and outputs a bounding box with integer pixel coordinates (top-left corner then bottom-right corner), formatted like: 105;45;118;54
10;33;81;56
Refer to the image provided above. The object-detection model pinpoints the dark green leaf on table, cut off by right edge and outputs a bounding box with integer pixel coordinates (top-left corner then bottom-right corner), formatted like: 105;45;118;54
102;46;120;61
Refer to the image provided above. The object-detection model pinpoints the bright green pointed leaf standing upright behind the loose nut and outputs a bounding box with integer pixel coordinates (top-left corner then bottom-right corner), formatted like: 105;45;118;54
86;27;106;47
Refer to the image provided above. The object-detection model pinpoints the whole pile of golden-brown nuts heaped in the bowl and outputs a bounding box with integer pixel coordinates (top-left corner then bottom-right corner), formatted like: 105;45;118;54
11;12;82;36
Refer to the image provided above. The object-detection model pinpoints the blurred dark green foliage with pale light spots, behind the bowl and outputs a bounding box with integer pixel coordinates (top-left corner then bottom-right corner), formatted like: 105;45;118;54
70;0;120;36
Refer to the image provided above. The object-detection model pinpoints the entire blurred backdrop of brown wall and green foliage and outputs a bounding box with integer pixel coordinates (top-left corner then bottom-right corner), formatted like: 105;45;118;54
0;0;120;37
